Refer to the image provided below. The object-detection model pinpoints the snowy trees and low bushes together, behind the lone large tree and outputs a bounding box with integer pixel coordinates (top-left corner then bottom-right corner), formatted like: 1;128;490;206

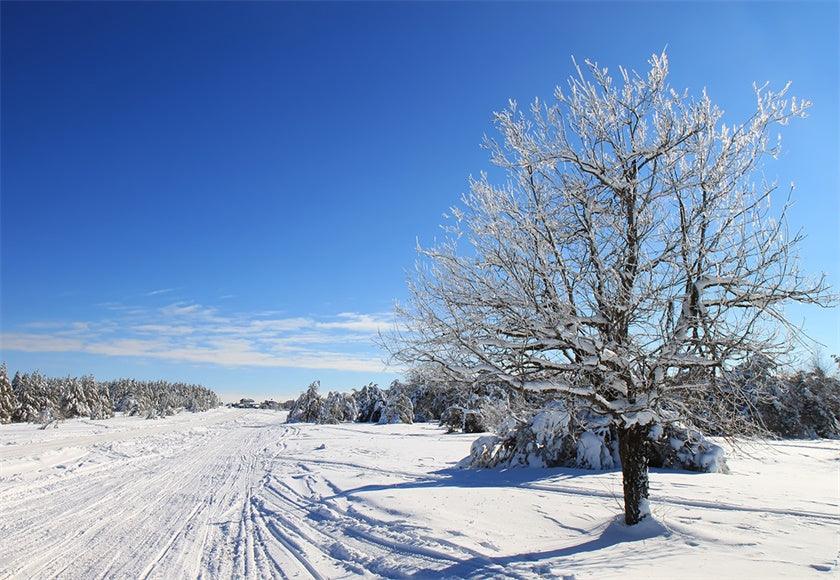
287;358;840;471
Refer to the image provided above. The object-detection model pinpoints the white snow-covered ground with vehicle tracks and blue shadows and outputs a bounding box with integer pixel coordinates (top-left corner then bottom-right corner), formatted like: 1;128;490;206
0;409;840;578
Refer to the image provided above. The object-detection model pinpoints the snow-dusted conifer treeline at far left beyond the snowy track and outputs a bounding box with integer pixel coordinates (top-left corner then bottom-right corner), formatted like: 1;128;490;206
0;363;219;423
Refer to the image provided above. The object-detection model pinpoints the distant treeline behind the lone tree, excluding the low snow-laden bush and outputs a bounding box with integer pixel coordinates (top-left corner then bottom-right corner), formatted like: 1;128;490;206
284;358;840;438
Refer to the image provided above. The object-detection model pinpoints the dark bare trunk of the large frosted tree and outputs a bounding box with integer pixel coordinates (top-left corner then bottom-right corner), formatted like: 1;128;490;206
618;425;648;526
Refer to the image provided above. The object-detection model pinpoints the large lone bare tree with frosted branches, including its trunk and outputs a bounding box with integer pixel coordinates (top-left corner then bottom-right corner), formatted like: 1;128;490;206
390;54;830;524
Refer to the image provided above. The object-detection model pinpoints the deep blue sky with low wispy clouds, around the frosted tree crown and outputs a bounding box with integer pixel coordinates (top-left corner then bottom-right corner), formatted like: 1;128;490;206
0;2;840;396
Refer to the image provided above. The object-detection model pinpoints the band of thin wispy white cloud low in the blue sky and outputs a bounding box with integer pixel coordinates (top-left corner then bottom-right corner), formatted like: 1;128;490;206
0;302;390;372
